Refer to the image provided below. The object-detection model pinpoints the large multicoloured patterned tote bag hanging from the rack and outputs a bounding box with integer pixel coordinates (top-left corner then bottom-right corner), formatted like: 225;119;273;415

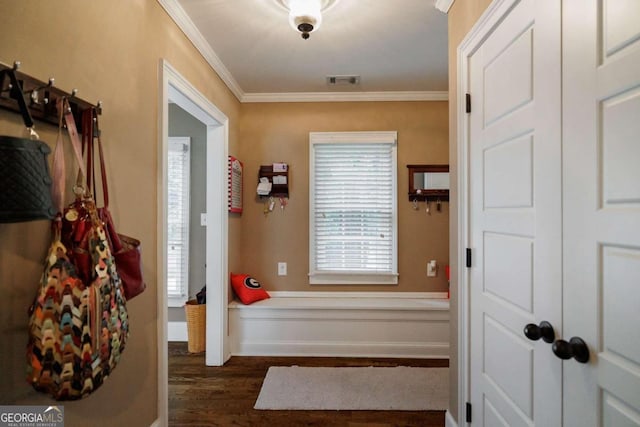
27;100;129;400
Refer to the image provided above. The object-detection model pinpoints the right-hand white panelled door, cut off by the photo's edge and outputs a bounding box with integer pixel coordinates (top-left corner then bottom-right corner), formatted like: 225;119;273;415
563;0;640;426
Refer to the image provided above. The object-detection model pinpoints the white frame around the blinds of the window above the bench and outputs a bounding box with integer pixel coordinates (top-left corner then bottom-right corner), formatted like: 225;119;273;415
309;131;398;285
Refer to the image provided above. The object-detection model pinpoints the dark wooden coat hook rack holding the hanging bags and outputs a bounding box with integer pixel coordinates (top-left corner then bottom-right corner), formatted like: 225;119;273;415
0;61;102;129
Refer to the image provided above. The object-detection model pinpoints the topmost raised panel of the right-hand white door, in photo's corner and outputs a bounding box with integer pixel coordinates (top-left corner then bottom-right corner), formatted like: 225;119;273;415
602;0;640;58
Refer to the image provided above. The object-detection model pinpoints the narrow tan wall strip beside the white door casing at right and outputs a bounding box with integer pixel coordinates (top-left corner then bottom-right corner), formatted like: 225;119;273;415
448;0;491;421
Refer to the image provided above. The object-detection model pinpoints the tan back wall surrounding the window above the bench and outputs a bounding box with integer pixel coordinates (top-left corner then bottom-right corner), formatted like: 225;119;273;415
236;102;449;292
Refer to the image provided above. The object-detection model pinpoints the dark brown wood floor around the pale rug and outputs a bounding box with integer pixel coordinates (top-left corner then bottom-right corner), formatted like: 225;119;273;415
169;342;448;427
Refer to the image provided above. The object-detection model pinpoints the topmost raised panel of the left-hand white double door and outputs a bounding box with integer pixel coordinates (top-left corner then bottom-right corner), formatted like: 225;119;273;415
484;29;533;126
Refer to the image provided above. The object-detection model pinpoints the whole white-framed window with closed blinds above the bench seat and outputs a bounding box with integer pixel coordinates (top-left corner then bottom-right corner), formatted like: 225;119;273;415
309;132;398;285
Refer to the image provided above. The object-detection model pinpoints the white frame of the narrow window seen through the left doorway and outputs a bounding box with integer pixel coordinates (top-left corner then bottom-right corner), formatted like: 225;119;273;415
165;136;191;307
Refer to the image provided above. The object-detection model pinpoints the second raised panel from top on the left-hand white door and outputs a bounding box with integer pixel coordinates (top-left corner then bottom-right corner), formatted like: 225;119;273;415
483;135;533;209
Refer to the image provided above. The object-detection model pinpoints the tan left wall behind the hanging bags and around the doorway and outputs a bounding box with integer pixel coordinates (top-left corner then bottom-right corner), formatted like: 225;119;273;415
0;0;240;427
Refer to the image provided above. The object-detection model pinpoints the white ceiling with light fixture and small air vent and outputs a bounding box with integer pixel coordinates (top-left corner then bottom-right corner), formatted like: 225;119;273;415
159;0;448;102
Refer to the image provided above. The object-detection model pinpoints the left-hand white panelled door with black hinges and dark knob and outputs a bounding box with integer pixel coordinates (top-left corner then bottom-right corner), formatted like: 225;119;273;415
468;0;562;427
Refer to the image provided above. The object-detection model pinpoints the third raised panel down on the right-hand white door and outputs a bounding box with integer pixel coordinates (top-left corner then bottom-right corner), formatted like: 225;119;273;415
602;246;640;369
